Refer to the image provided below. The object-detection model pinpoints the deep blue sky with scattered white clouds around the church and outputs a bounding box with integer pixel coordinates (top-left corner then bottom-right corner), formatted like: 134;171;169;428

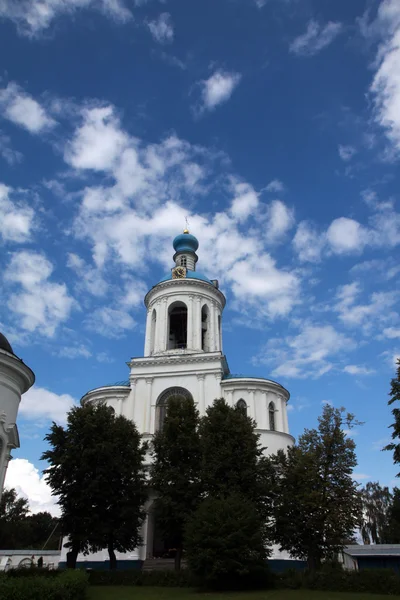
0;0;400;514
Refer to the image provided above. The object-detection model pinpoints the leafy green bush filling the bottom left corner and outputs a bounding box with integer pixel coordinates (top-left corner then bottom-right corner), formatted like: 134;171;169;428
0;569;88;600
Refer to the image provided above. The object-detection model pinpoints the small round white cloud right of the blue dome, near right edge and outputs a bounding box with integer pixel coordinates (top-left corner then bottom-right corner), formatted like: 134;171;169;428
326;217;368;254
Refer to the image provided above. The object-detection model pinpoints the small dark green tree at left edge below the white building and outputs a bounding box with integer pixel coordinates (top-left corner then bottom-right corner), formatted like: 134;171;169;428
0;488;29;550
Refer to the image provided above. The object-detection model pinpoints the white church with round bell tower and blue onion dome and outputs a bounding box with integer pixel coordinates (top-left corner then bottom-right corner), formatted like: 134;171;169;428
61;229;294;567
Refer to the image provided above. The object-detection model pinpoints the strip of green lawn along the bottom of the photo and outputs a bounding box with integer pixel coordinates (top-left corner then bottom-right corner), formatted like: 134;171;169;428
88;586;400;600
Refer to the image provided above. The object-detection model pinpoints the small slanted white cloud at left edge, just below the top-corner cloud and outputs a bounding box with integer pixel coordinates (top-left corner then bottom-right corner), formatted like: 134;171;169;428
0;81;56;134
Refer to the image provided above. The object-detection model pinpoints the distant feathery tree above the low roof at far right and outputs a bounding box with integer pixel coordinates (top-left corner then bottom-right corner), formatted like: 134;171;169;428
360;481;392;544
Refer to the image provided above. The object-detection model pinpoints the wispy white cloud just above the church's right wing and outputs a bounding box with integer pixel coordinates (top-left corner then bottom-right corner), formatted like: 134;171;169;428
256;324;354;379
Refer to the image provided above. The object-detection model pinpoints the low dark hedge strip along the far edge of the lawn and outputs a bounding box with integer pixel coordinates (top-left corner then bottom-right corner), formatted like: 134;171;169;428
89;569;198;587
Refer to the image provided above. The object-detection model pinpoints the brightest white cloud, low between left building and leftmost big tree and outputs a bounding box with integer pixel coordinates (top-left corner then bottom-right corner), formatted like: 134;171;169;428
5;458;60;517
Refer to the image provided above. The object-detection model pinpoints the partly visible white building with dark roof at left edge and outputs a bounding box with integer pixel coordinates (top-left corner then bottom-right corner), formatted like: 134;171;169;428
0;333;35;500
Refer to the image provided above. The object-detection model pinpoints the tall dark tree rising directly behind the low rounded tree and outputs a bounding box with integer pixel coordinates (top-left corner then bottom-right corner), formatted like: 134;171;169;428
199;398;272;522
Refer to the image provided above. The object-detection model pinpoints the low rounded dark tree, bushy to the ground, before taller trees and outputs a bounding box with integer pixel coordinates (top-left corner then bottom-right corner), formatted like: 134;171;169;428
186;494;268;589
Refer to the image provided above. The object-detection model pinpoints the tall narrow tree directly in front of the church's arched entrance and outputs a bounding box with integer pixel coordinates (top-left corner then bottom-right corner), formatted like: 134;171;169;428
150;397;201;570
